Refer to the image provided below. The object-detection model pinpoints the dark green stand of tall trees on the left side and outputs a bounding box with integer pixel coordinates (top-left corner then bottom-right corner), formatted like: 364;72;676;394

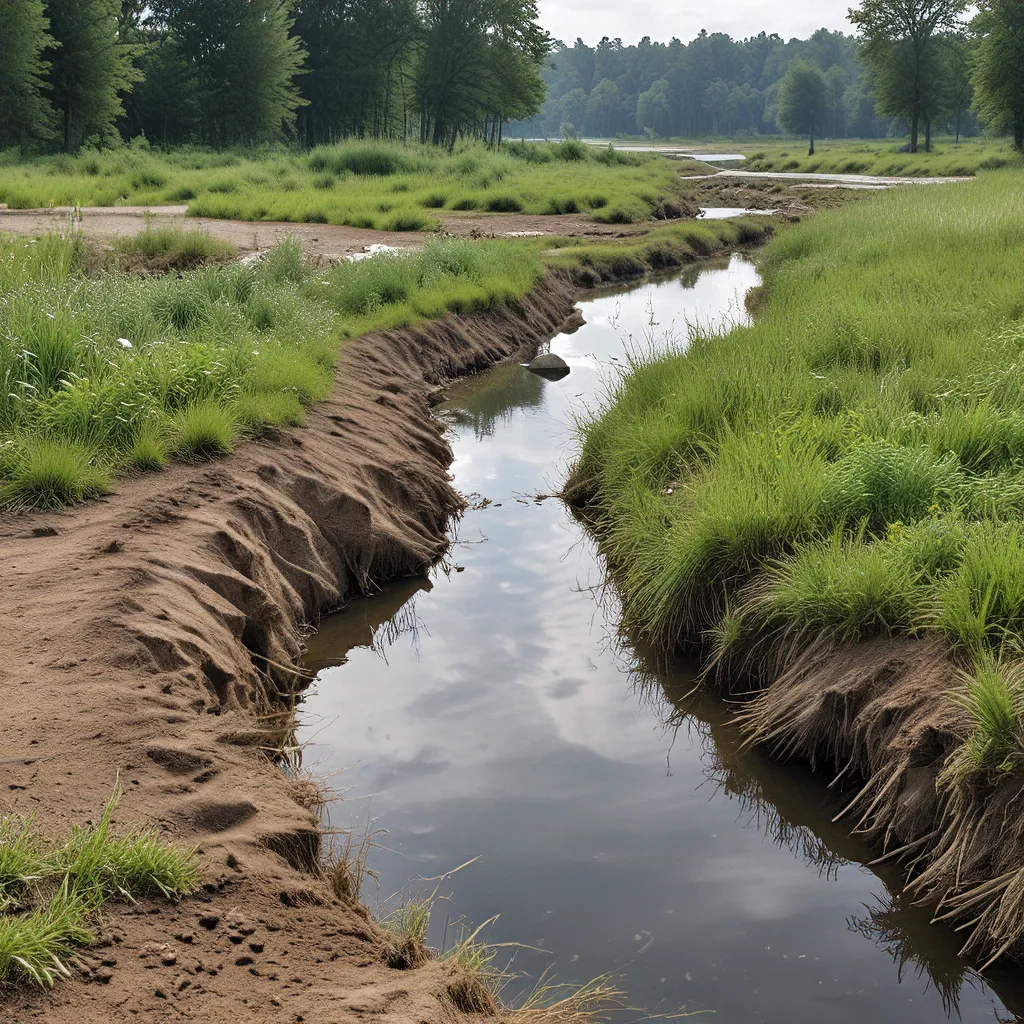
0;0;551;153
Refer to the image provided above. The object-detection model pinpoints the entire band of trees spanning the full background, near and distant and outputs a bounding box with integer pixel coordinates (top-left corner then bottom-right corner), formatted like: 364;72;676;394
0;0;1024;152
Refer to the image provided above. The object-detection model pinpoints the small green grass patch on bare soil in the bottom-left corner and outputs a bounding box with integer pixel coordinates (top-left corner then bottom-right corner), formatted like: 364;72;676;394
0;792;200;988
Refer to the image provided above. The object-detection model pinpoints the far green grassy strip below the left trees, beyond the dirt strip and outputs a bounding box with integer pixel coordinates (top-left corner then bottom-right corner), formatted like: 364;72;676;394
0;141;679;231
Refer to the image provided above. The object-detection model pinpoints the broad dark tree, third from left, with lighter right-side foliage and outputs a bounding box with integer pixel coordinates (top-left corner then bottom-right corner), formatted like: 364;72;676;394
161;0;305;146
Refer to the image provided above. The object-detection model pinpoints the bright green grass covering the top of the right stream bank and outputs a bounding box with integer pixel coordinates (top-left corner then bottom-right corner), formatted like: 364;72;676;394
573;171;1024;781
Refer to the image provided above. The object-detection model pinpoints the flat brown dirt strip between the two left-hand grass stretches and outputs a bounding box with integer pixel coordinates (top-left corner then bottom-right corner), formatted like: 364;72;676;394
0;206;651;257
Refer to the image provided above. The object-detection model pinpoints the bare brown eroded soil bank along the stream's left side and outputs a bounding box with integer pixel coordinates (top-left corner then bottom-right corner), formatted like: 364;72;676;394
0;274;574;1024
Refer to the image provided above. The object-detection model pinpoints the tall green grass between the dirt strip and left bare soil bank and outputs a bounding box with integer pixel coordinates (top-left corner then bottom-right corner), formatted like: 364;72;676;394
0;231;542;511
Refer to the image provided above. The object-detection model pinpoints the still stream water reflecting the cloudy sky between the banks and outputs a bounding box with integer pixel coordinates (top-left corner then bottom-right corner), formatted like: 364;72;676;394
303;257;1024;1024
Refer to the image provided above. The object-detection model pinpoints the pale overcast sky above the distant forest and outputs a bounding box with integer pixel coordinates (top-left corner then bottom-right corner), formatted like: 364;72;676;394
540;0;857;46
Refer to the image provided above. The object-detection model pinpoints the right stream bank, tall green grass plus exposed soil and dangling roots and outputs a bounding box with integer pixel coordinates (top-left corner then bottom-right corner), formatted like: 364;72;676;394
567;167;1024;959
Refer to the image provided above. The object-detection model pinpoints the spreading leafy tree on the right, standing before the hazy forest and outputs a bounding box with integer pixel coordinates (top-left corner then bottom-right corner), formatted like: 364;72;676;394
849;0;967;153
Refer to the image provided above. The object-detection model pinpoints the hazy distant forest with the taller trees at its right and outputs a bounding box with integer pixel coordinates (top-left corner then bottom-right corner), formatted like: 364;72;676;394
514;0;1024;152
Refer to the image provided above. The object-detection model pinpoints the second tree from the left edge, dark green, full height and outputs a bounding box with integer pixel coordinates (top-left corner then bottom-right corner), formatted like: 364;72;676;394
45;0;141;153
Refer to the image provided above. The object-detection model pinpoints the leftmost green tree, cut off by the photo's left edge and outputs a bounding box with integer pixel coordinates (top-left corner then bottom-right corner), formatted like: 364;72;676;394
0;0;54;150
